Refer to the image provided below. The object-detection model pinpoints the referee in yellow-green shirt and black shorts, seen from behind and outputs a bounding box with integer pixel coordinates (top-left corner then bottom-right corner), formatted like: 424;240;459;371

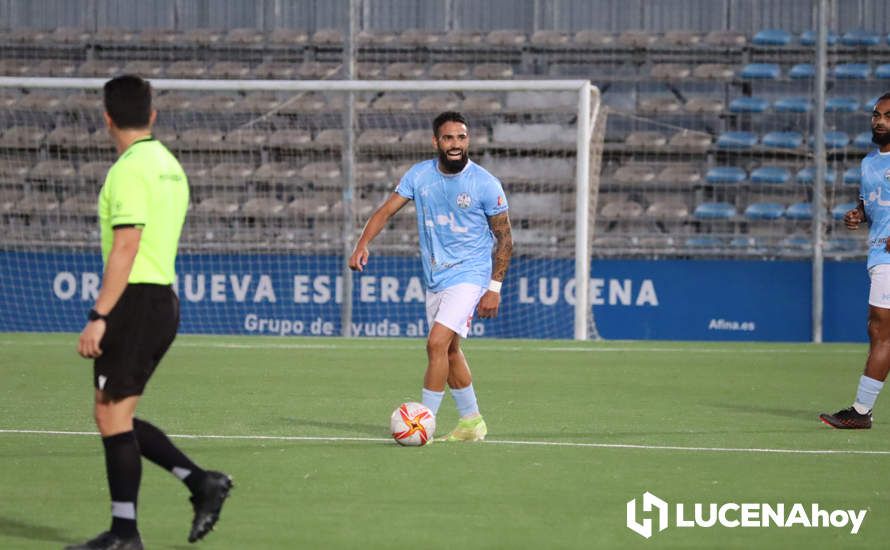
68;75;232;550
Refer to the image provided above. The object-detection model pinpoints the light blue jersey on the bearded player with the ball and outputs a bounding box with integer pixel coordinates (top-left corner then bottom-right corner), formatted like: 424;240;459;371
396;159;507;292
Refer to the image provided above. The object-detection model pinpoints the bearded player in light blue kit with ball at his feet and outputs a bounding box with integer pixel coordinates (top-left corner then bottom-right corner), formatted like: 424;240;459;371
349;112;513;441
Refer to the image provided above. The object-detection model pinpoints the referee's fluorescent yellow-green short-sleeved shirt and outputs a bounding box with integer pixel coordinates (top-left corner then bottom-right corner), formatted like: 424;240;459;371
99;137;189;285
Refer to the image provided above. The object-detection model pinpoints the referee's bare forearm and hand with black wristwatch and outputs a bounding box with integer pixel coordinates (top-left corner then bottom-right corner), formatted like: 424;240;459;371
77;226;142;358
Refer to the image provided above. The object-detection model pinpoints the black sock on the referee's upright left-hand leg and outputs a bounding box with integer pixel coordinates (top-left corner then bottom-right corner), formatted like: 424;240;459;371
102;431;142;538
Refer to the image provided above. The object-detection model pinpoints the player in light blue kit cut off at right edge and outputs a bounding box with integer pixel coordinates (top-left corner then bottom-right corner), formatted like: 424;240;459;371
819;93;890;430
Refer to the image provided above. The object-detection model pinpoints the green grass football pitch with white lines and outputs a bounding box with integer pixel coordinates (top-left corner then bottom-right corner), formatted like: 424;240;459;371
0;334;890;549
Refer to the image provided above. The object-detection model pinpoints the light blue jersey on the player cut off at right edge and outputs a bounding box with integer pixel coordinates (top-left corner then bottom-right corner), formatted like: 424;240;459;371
859;150;890;268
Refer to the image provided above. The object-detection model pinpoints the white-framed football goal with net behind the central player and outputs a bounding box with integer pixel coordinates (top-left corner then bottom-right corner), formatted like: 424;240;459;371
0;77;604;338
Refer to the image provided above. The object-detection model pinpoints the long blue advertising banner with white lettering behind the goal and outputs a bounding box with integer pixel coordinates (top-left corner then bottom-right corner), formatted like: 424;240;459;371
0;252;868;341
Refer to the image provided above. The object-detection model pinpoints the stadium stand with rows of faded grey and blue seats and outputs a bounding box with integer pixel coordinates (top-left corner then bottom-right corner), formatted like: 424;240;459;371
0;4;890;255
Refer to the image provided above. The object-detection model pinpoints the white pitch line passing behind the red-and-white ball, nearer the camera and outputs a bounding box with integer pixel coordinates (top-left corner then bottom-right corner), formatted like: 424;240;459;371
0;429;890;456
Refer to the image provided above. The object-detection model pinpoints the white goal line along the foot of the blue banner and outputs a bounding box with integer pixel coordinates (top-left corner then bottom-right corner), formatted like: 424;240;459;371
0;340;865;355
